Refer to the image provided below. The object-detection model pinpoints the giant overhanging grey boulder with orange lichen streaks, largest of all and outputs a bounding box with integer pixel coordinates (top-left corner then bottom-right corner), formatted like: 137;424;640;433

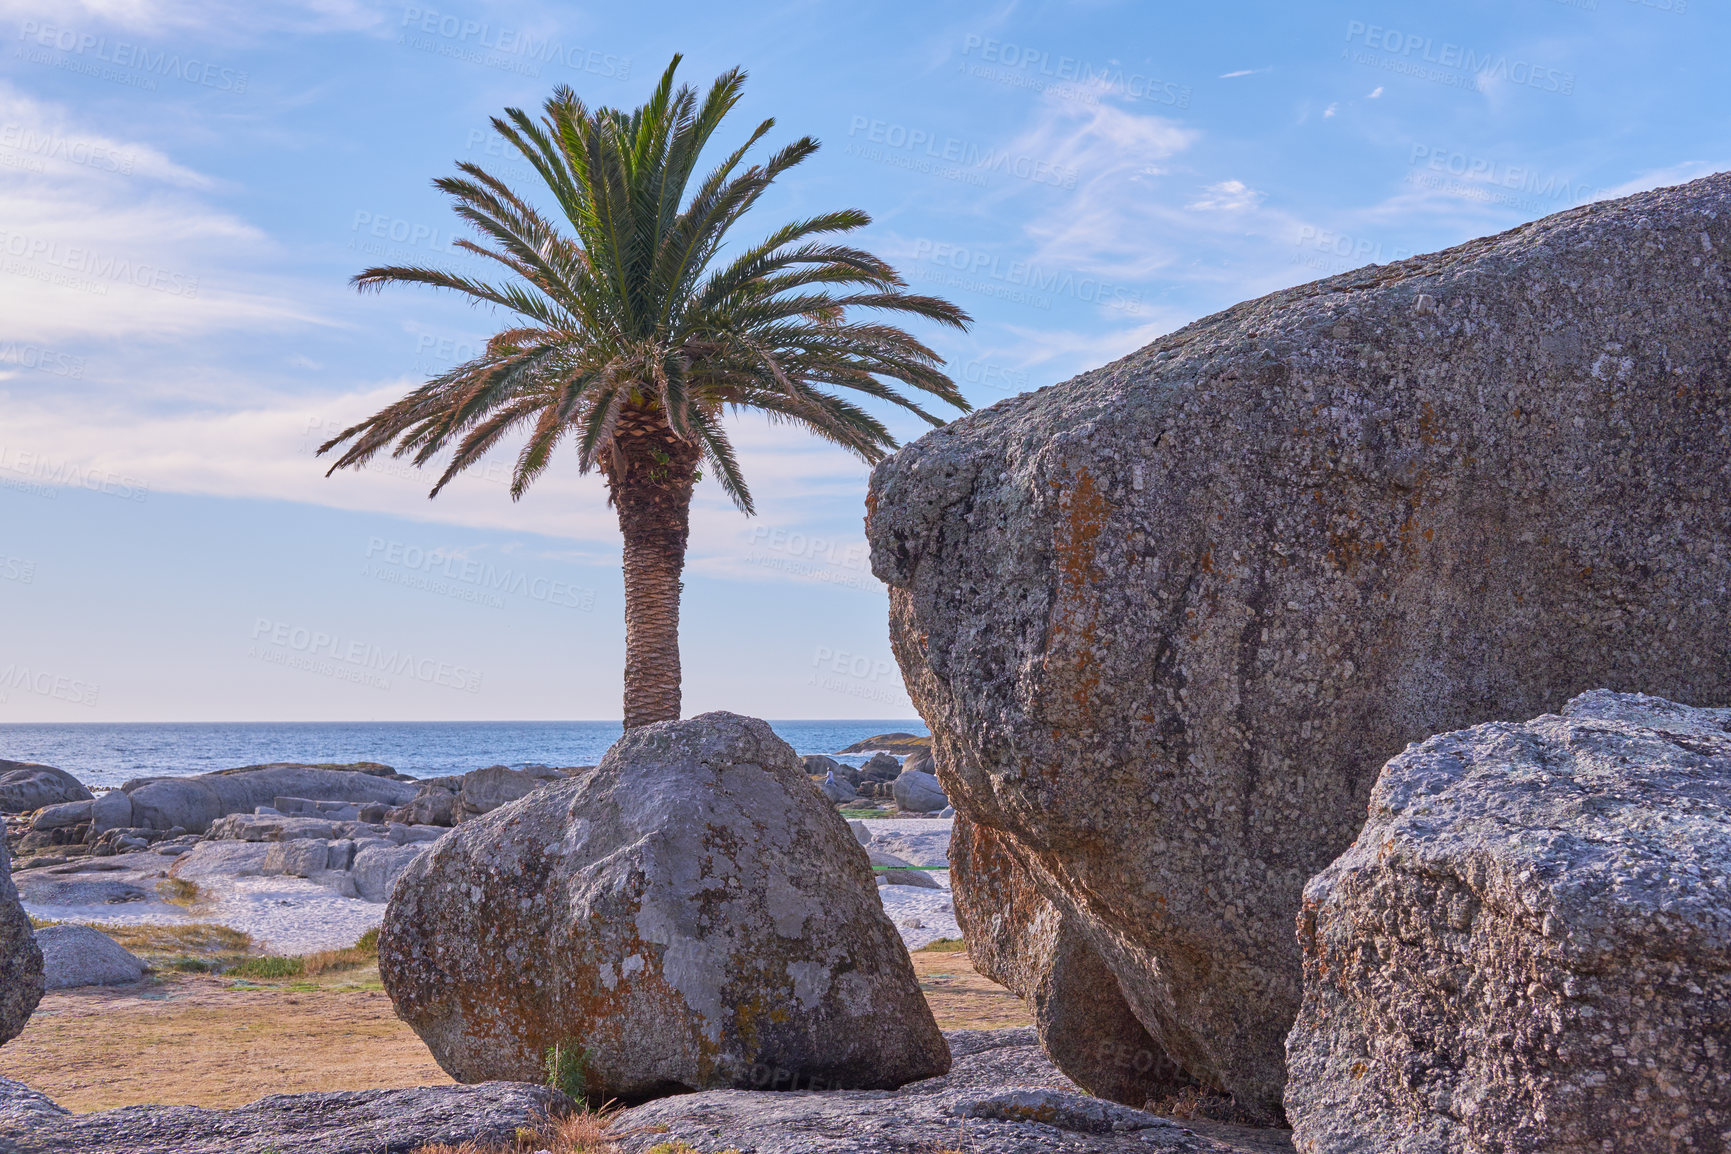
867;175;1731;1118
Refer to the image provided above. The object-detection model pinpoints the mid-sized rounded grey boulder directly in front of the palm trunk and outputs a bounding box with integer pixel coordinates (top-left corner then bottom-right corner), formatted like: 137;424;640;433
379;713;949;1102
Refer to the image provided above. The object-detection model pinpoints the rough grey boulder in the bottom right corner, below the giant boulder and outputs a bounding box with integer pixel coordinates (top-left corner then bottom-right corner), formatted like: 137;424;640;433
1286;692;1731;1154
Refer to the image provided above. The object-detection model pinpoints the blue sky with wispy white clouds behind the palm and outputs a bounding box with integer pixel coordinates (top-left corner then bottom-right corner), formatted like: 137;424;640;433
0;0;1731;721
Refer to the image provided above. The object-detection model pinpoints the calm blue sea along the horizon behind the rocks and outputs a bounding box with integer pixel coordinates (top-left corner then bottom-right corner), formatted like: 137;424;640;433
0;721;926;785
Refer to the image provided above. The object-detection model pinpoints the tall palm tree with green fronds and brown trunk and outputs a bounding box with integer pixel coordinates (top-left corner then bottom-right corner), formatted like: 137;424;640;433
319;55;971;728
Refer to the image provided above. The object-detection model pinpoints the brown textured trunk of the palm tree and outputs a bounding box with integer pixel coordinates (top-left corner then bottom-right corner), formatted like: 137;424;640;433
606;414;699;728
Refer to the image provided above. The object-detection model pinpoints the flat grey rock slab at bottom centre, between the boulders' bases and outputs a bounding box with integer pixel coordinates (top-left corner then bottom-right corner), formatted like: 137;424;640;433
613;1028;1291;1154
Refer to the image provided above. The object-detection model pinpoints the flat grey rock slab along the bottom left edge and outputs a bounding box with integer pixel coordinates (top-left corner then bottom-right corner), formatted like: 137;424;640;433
0;1078;571;1154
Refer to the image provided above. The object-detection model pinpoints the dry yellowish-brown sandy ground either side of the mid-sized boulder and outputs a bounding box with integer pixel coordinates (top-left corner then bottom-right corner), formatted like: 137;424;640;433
0;950;1028;1112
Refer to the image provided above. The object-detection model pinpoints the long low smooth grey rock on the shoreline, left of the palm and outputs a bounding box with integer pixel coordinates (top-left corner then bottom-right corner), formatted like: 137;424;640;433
121;763;419;836
